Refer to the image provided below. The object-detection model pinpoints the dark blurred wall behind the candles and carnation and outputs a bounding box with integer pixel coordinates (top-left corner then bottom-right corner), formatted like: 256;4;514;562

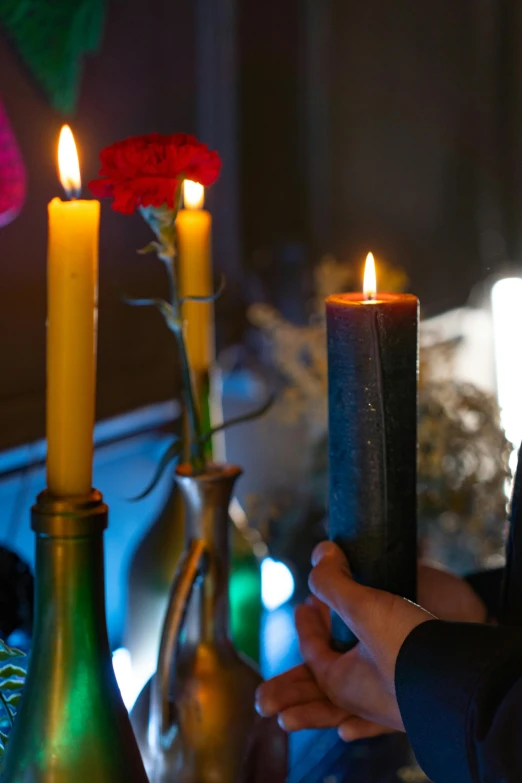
0;0;522;447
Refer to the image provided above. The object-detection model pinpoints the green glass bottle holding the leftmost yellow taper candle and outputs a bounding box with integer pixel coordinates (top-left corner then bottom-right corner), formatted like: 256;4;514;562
2;490;147;783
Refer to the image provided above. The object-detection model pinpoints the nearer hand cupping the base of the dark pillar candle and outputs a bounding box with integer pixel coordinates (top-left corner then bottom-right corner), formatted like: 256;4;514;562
257;541;448;740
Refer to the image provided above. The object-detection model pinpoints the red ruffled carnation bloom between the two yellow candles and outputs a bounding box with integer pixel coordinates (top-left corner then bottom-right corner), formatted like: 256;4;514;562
89;133;221;215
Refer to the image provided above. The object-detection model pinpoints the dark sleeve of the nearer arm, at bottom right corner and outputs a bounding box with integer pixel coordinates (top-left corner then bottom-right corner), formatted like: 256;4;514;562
395;620;522;783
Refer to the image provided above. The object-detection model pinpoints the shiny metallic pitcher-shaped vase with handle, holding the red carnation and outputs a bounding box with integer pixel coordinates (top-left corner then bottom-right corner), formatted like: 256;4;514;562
131;465;286;783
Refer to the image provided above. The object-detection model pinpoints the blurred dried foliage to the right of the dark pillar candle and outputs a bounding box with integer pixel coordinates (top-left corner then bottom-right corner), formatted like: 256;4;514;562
418;345;513;570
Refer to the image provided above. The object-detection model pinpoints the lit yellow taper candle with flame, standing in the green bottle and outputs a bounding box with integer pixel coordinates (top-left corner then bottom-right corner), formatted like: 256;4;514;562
47;126;100;497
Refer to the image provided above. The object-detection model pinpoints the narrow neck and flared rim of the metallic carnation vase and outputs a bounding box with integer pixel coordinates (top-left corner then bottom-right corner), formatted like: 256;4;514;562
176;466;240;643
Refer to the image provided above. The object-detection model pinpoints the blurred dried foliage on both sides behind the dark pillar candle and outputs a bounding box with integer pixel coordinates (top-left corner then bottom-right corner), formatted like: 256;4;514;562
249;256;512;573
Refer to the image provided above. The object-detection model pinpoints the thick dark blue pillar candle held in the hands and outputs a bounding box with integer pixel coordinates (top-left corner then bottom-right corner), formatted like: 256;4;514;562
326;294;419;650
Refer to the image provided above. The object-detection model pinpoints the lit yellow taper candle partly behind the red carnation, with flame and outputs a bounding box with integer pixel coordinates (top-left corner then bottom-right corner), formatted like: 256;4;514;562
176;180;215;376
